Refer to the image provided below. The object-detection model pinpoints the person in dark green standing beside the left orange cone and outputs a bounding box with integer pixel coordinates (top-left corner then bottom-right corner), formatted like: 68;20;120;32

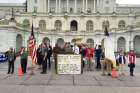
20;47;28;74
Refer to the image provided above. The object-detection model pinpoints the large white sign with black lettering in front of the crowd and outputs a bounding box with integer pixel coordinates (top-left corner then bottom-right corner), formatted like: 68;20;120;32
57;54;81;74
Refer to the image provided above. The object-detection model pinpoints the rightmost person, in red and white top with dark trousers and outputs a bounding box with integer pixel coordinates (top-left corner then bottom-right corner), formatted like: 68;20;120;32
128;50;136;76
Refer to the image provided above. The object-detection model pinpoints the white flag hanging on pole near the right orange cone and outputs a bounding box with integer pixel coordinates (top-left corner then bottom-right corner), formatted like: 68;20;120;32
104;27;116;68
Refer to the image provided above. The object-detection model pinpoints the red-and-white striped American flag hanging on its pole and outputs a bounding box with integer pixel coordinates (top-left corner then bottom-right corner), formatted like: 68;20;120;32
28;24;37;64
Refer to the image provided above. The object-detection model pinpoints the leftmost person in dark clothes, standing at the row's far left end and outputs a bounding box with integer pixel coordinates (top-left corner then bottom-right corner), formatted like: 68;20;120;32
7;47;16;74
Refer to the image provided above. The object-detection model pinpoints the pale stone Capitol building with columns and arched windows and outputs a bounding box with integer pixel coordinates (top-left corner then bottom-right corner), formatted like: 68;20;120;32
0;0;140;53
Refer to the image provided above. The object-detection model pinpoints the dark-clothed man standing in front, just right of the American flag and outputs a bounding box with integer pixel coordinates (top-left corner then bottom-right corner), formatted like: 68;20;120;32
41;42;48;74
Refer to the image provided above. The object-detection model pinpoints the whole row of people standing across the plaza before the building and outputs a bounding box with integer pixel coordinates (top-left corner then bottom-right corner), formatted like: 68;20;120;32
7;42;136;76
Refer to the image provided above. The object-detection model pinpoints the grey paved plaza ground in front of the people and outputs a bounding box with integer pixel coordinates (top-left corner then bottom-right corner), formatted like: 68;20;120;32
0;59;140;93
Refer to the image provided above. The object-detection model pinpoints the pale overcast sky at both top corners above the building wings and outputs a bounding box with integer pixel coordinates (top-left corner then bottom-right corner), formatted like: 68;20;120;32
0;0;140;4
